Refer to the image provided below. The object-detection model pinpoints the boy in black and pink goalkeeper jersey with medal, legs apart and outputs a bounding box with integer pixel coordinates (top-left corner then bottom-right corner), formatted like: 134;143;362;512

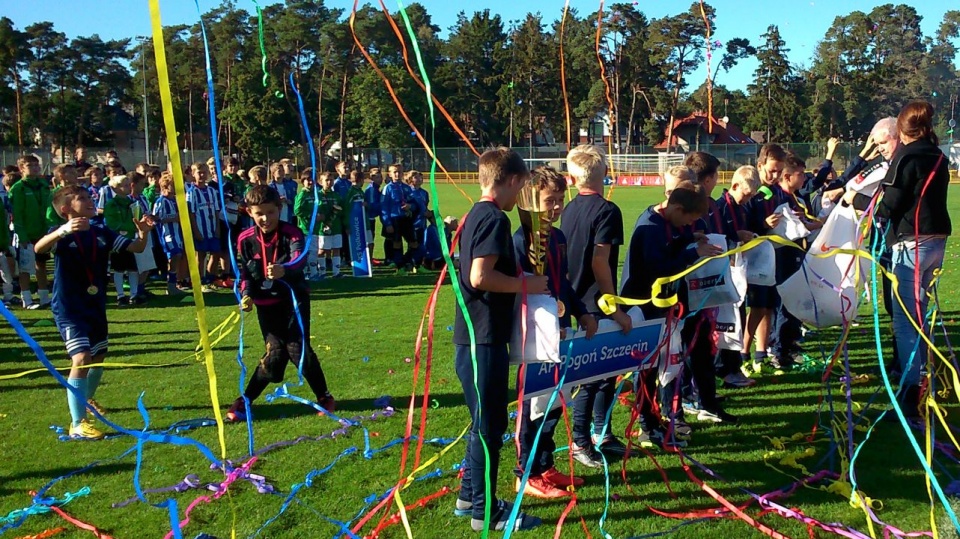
227;185;335;421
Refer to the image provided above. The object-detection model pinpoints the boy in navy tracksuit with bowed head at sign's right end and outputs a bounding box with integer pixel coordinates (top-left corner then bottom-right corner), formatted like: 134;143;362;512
620;179;719;448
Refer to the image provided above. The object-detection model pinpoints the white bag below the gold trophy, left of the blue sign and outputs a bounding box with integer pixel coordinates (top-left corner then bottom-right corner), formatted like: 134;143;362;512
510;280;560;365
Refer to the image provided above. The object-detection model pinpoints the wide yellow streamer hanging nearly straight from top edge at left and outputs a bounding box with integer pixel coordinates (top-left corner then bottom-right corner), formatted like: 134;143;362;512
149;0;228;464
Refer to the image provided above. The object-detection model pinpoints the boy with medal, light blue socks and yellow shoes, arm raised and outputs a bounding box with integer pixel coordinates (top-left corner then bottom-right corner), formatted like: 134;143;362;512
34;185;153;440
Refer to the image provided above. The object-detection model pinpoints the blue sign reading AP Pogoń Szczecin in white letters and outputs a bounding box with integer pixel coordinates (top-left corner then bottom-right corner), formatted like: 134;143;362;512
523;318;666;400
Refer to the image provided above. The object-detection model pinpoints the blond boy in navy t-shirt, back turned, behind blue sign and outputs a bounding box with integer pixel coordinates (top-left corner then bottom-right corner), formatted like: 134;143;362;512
560;144;633;468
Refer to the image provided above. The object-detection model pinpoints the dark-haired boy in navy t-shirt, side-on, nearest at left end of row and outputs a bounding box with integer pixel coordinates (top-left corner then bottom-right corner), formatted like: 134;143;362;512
453;148;549;531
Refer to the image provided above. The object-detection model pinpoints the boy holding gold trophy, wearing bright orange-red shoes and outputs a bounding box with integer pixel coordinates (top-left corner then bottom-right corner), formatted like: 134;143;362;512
513;166;597;498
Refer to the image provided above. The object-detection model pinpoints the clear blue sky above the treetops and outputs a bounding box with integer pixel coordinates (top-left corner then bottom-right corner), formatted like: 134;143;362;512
0;0;960;89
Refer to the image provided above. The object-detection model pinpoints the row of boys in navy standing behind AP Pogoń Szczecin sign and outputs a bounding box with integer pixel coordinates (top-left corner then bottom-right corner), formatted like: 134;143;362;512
450;139;900;530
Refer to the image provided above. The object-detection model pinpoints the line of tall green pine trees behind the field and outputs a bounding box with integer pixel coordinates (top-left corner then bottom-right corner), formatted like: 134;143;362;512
0;0;960;165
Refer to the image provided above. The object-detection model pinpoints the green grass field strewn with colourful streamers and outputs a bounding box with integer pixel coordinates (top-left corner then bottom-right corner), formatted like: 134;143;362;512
0;186;960;539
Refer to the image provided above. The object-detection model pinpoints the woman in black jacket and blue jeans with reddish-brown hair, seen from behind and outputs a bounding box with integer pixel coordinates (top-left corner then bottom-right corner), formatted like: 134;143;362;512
844;101;951;417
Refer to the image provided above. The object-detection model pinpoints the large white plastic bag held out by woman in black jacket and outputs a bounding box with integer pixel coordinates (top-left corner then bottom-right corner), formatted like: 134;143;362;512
777;205;866;328
